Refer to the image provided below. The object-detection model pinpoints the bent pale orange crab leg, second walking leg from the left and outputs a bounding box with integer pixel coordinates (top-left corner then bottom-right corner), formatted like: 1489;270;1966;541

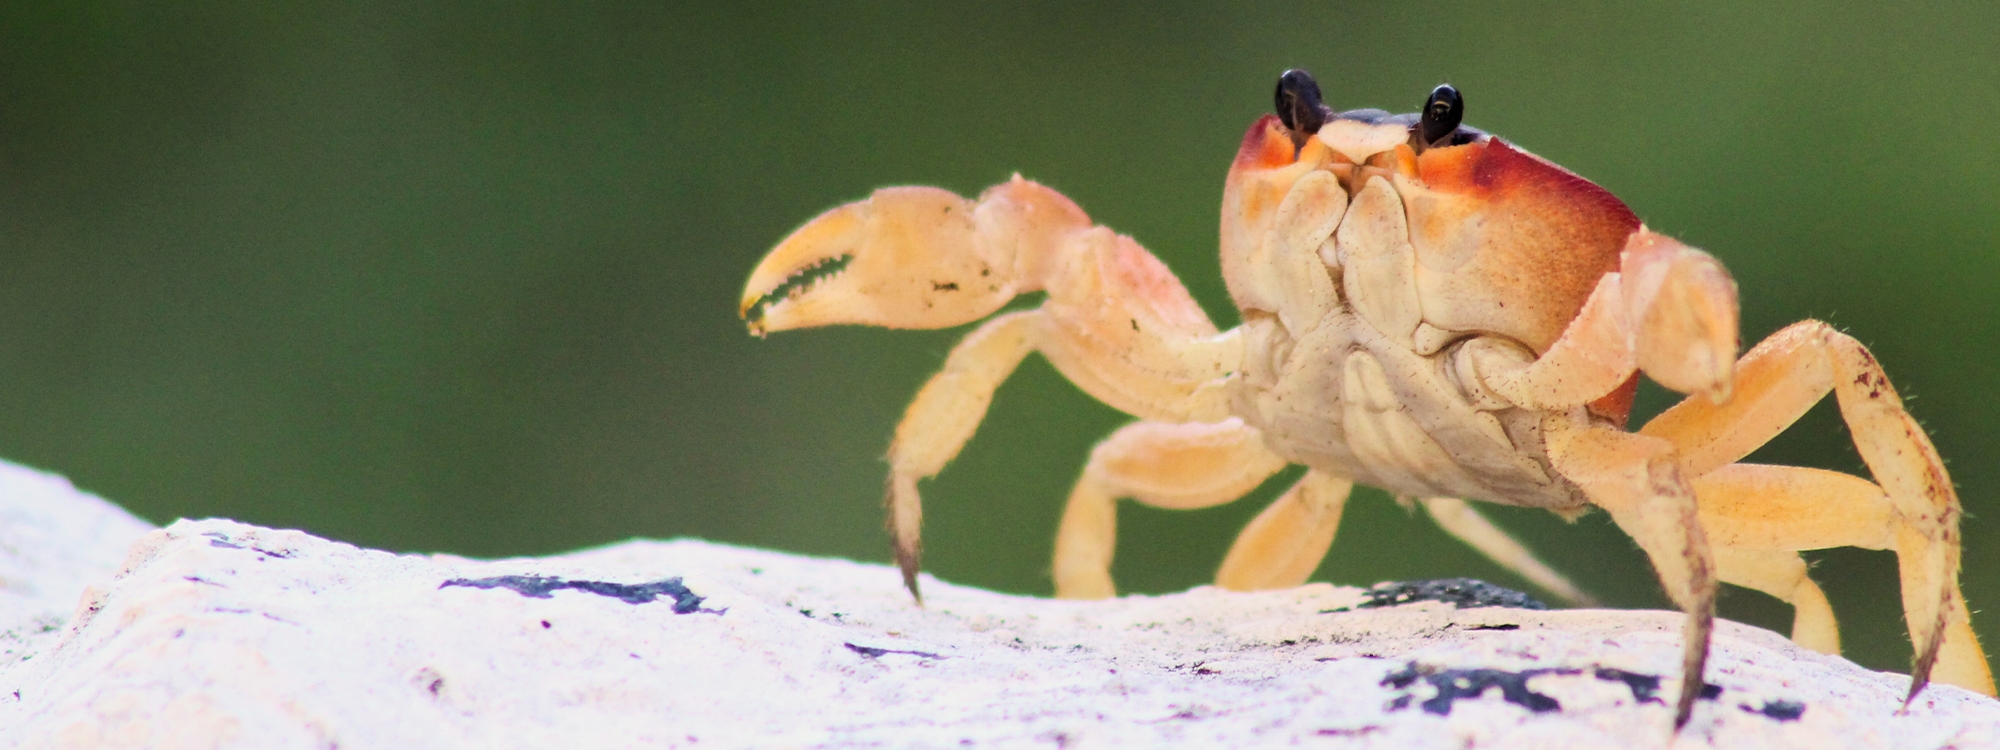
1054;418;1310;598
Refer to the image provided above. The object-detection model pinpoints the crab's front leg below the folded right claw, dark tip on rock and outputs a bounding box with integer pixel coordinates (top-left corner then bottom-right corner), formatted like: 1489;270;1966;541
1544;416;1716;728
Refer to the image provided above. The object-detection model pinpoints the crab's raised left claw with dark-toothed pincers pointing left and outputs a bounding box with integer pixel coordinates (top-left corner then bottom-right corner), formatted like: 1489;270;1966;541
740;176;1090;336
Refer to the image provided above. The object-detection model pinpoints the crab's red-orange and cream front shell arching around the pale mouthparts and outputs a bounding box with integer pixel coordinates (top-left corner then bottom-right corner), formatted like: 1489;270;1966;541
1222;114;1640;364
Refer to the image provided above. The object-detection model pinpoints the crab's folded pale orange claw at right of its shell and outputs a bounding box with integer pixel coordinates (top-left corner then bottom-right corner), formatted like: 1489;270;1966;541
1620;226;1740;404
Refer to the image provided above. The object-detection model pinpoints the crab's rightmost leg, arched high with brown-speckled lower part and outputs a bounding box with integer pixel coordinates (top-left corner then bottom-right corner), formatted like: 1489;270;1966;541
1640;320;1994;698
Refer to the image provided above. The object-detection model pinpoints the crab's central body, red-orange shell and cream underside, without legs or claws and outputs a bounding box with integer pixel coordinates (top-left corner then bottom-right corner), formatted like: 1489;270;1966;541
1222;112;1656;514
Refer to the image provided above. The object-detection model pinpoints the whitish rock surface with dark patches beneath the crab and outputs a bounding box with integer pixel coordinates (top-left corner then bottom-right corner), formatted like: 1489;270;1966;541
0;466;2000;748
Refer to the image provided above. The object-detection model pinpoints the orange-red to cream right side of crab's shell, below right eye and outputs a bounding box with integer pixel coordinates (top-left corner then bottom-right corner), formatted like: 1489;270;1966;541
1404;138;1640;354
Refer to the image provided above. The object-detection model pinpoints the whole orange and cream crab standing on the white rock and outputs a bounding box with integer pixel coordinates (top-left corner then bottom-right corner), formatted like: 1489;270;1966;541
740;70;1994;728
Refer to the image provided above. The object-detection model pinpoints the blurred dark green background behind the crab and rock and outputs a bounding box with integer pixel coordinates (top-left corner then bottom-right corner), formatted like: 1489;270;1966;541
0;2;2000;670
